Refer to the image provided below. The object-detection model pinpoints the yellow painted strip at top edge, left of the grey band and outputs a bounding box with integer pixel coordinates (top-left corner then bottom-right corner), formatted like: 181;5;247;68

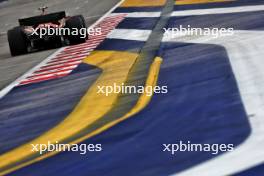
121;0;166;7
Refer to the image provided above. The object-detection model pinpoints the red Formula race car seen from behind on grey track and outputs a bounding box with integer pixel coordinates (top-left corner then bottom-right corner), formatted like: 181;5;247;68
7;7;88;56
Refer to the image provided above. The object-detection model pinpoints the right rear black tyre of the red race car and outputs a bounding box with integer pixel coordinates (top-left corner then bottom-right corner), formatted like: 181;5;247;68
65;15;87;45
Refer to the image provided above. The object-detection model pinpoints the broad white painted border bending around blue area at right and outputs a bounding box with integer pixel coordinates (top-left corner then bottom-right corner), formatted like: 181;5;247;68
166;31;264;176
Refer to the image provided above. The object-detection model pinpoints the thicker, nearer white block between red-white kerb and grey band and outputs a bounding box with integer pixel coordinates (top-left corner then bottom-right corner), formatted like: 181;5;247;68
107;29;151;41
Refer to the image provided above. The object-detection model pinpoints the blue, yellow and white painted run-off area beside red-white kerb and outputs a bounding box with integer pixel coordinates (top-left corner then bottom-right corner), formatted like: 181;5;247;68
0;0;264;176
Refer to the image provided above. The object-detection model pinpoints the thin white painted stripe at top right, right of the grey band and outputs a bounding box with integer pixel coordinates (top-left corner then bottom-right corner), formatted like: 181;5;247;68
171;5;264;16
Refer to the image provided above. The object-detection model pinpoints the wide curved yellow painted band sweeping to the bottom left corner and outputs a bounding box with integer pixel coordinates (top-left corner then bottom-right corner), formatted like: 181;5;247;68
0;51;138;173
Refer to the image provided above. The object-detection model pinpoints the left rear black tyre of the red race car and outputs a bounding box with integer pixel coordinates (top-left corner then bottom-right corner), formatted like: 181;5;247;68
7;26;28;56
